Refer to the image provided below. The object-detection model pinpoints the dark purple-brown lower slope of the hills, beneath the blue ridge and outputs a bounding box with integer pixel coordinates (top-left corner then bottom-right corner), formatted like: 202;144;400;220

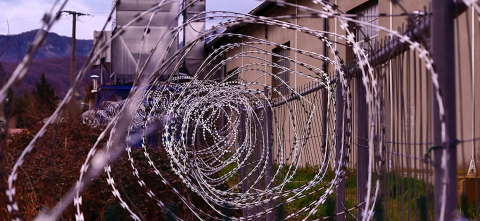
0;56;101;98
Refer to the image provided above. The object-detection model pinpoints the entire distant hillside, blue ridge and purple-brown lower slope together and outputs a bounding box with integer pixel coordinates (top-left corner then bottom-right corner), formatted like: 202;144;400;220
0;30;100;98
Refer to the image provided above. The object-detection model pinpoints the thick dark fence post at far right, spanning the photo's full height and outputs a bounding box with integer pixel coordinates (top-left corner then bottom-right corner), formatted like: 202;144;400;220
430;0;458;220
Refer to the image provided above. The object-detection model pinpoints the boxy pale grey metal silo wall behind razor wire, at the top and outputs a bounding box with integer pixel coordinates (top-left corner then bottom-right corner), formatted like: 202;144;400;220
112;0;180;84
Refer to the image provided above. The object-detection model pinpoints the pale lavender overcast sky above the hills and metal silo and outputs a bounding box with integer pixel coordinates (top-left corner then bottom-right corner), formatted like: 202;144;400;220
0;0;260;39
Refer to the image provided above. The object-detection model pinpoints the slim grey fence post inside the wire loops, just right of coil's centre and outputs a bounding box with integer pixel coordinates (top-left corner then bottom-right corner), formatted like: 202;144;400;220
263;87;274;221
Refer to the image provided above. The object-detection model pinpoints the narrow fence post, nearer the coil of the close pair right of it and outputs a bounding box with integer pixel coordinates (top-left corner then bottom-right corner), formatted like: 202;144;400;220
335;80;345;221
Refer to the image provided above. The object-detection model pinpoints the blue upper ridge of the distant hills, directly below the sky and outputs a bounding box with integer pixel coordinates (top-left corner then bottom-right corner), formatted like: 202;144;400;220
0;30;93;63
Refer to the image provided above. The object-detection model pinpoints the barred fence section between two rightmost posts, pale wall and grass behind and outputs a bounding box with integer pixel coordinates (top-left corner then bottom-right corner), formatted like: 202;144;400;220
366;35;434;220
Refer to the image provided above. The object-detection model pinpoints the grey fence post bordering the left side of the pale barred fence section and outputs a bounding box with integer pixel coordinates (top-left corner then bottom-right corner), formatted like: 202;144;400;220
355;76;368;219
